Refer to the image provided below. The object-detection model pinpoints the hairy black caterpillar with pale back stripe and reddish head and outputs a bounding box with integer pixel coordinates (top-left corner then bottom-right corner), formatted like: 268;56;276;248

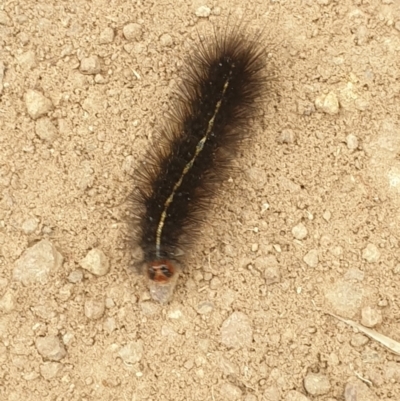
132;26;267;303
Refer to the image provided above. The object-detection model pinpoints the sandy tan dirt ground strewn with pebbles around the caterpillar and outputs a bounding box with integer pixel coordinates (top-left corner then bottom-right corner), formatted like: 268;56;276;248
0;0;400;401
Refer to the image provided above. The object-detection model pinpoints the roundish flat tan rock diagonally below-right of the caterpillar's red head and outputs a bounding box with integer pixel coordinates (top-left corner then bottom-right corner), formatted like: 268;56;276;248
221;312;253;348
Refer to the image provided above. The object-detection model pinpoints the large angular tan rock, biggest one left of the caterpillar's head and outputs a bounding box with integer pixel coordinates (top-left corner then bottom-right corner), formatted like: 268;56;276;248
13;239;64;285
